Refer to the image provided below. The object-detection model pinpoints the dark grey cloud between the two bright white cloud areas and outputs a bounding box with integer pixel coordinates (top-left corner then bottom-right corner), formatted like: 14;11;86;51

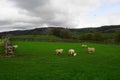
10;0;69;26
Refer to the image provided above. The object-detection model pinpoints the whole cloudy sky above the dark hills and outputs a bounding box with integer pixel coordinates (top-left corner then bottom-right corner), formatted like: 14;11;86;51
0;0;120;32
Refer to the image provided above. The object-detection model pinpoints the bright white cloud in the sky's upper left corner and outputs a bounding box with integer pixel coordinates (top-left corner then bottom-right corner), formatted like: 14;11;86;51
0;0;40;21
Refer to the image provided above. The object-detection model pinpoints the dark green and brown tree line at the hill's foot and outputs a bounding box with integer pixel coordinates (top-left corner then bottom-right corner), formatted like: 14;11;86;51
46;28;120;43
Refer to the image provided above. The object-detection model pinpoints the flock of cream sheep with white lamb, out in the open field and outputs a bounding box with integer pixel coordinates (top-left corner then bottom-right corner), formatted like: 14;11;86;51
55;44;95;56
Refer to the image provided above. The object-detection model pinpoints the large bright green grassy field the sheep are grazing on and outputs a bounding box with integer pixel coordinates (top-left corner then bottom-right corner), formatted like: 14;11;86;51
0;41;120;80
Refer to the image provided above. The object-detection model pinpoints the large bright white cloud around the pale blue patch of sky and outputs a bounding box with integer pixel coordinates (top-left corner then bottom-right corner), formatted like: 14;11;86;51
51;0;120;28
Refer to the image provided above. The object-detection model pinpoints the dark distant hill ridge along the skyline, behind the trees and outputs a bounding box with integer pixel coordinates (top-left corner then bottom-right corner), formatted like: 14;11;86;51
0;25;120;36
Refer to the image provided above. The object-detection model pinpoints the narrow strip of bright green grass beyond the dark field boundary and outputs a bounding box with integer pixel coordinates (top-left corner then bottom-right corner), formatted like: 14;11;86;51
11;35;60;39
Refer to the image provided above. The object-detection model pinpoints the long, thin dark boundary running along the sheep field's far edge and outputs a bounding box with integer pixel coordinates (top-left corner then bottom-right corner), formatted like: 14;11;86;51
11;38;120;45
